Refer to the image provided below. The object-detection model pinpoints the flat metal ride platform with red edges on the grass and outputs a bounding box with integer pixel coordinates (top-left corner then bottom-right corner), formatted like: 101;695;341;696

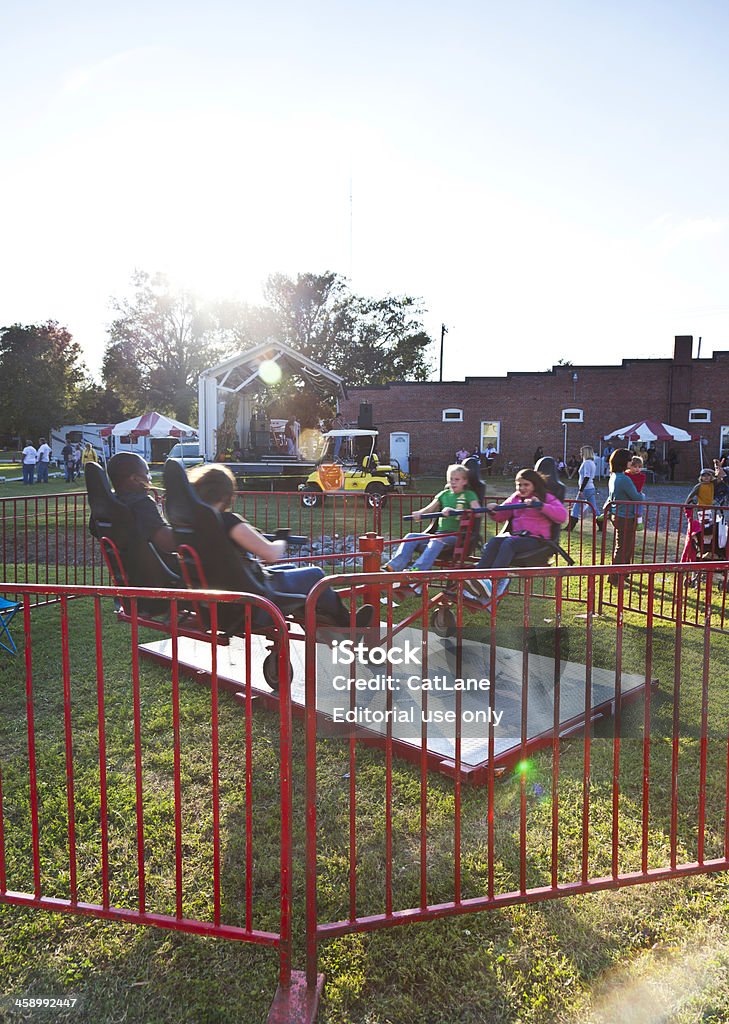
139;629;646;784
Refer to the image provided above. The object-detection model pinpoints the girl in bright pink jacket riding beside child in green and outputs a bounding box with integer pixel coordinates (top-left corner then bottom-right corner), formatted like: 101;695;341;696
478;469;567;599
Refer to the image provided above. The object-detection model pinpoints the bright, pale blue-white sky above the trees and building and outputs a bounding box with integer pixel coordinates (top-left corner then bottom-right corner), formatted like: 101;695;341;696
0;0;729;380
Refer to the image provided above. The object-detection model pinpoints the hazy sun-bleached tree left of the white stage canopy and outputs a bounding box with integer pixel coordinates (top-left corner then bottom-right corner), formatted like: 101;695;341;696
103;271;232;423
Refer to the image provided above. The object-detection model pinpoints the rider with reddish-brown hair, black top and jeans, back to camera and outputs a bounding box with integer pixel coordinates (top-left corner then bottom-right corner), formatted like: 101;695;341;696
187;463;375;628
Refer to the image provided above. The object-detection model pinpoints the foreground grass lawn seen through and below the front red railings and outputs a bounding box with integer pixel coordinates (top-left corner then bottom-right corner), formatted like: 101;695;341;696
0;569;729;1024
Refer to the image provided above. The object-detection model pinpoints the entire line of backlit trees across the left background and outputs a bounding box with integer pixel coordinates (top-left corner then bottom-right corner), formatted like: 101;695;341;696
0;271;432;438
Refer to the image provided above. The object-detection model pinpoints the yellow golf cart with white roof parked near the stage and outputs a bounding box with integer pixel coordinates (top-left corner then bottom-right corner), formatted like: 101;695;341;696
299;430;406;508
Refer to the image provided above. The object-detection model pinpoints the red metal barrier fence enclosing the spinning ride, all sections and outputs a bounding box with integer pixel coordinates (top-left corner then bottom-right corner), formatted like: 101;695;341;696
0;494;729;1015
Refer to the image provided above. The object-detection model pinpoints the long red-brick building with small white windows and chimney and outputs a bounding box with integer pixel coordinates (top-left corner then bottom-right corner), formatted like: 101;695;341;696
341;335;729;479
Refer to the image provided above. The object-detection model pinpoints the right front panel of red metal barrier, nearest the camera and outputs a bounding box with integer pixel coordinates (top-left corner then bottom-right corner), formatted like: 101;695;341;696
305;561;729;984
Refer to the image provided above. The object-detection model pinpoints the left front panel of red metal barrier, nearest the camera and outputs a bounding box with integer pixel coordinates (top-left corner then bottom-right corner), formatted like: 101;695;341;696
0;585;292;987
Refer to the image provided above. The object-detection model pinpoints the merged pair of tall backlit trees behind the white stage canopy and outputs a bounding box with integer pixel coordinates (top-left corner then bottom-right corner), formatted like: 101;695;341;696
103;271;431;422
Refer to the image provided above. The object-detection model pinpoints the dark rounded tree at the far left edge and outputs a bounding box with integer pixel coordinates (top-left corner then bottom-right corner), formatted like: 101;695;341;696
0;321;88;440
